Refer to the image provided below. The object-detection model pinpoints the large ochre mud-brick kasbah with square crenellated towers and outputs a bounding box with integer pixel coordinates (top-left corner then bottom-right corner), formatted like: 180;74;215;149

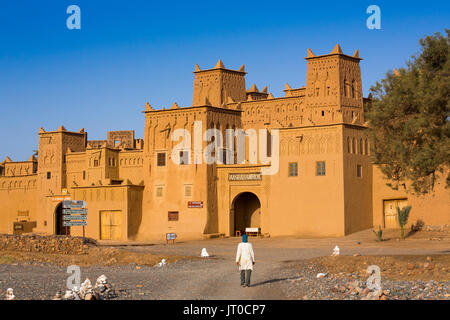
0;45;450;241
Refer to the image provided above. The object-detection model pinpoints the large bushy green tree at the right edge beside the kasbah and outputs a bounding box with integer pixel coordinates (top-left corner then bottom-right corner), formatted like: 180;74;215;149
365;30;450;194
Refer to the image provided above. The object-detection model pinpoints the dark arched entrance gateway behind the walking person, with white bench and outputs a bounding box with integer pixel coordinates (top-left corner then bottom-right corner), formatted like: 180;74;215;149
230;192;261;236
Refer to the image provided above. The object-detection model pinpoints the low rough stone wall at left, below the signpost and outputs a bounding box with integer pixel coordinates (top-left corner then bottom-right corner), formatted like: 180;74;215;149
0;234;96;254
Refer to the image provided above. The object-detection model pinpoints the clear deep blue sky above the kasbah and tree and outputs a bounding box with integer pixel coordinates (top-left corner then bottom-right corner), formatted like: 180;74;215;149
0;0;450;161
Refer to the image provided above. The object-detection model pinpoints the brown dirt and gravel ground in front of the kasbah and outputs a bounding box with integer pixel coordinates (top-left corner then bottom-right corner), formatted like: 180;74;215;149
0;230;450;300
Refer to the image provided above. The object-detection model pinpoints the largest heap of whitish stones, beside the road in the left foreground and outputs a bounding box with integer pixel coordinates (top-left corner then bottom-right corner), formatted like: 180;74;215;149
53;275;118;300
